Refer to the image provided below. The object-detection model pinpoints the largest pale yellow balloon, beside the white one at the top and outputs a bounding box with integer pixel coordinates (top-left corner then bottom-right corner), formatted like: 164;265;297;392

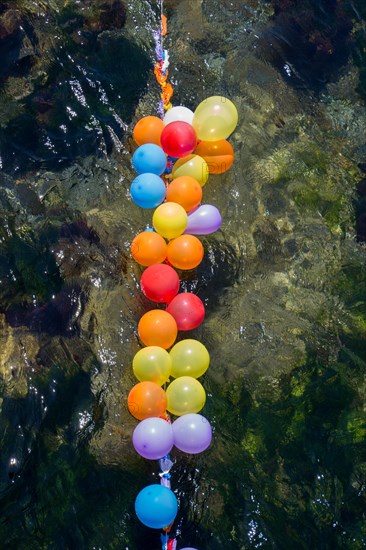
192;96;238;141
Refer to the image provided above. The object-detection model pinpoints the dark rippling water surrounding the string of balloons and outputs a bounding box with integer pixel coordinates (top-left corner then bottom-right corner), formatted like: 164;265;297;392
0;0;366;550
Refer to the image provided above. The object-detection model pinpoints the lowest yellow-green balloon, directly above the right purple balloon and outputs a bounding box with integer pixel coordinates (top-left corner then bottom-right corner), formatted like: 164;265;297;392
166;376;206;416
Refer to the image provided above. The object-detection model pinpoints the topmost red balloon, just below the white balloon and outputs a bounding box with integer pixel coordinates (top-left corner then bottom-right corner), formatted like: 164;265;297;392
160;120;197;158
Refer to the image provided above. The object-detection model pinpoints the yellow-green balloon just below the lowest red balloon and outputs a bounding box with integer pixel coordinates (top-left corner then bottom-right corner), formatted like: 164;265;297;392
169;338;210;378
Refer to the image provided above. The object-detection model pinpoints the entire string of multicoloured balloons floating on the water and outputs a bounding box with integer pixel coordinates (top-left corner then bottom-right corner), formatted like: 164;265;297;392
127;96;238;540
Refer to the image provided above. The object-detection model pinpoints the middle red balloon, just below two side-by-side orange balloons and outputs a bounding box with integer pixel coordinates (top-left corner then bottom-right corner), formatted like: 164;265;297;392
140;264;179;303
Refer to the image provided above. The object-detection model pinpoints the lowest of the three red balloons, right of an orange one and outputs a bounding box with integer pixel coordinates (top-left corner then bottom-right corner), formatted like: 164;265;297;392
166;292;205;330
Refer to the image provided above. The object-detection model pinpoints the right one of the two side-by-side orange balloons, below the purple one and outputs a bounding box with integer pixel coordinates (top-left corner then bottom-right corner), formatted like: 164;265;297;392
168;235;204;269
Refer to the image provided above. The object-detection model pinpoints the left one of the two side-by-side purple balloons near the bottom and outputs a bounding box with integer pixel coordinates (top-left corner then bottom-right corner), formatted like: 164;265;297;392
132;416;174;460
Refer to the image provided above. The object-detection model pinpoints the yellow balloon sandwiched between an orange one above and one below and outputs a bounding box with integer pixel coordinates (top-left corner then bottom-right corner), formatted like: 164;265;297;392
132;346;172;386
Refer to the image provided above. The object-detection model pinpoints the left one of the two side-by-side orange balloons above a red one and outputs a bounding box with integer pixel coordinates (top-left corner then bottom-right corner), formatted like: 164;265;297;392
131;231;168;266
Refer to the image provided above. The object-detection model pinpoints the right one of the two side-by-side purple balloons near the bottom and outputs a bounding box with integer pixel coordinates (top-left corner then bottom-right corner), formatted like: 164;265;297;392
173;414;212;455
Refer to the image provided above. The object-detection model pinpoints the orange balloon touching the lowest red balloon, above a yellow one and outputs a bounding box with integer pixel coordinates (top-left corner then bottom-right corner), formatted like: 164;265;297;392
138;309;178;349
